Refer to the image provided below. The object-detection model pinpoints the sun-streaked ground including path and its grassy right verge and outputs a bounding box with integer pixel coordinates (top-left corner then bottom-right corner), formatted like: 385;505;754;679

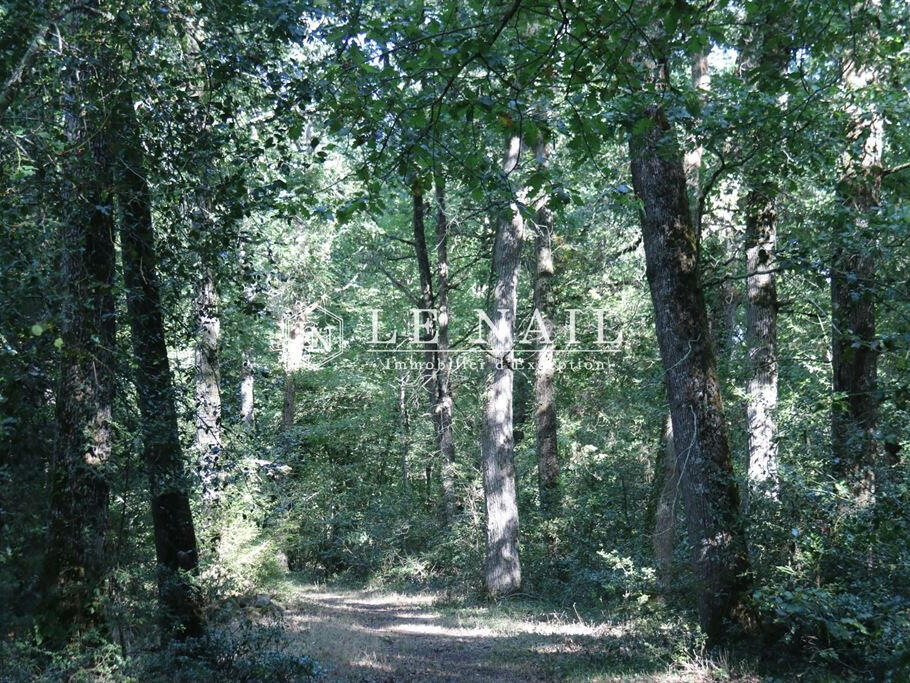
274;584;757;683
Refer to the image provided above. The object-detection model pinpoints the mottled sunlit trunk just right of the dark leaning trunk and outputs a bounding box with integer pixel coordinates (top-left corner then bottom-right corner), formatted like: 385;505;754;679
196;268;222;504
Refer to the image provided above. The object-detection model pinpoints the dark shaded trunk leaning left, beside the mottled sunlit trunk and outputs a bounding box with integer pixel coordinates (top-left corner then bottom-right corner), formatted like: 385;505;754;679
116;93;202;637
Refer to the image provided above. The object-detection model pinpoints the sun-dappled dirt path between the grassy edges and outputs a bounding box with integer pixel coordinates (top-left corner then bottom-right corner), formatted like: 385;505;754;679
286;586;622;682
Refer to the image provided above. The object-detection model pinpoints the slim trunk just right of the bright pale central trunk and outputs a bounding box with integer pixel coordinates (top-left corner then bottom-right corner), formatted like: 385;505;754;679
534;136;560;517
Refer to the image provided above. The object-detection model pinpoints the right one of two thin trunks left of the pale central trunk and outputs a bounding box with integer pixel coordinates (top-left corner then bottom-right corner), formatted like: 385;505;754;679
435;175;458;524
